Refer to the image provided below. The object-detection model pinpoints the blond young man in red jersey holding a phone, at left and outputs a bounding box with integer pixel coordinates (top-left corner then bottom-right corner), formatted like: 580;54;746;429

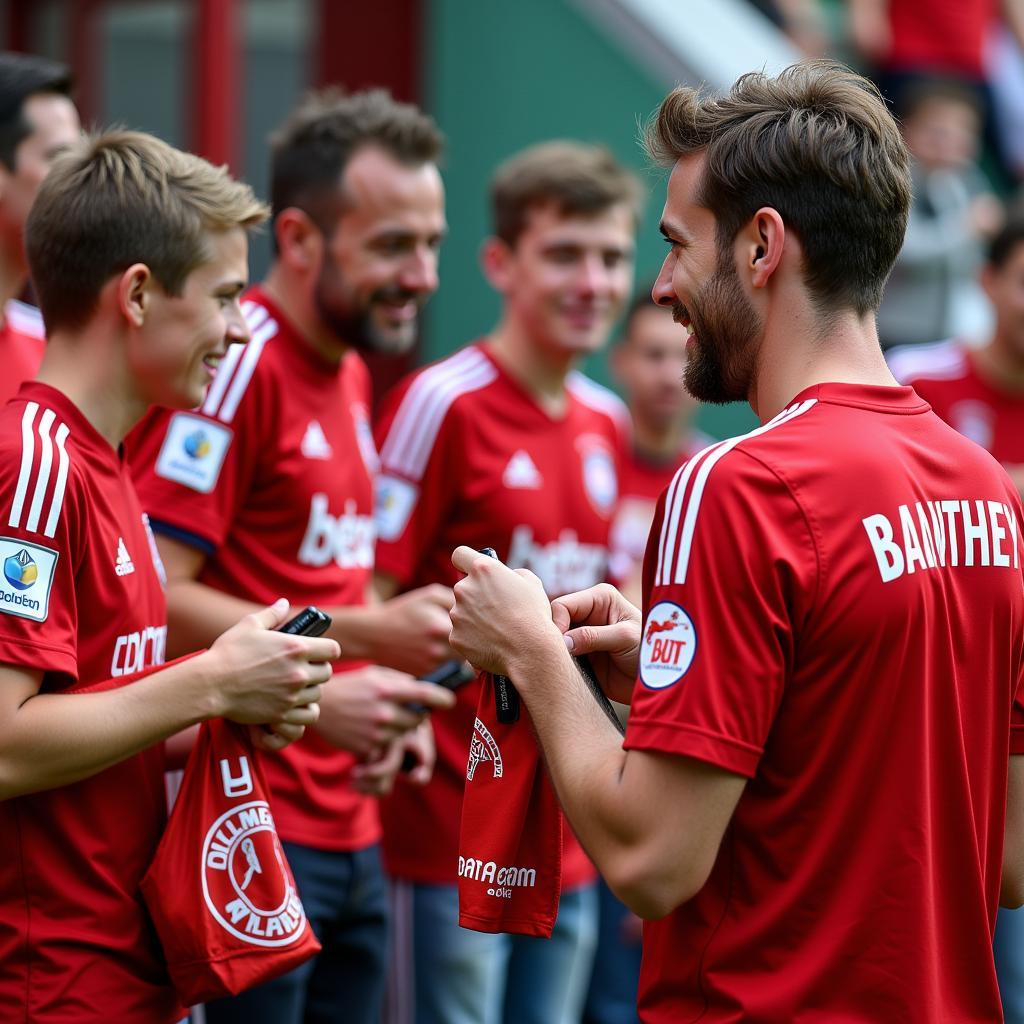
0;132;338;1024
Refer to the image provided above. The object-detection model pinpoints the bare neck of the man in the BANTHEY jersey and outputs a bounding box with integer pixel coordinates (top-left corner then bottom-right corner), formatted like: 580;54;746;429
749;298;897;423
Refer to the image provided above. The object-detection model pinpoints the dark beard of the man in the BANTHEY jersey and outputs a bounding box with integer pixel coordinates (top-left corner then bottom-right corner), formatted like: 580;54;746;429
674;248;764;406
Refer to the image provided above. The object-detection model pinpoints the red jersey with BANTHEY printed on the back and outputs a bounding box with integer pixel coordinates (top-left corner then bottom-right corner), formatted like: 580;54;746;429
626;384;1024;1024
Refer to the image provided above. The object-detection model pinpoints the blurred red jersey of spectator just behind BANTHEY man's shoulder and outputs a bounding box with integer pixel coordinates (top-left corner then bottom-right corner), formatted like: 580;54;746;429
608;430;713;582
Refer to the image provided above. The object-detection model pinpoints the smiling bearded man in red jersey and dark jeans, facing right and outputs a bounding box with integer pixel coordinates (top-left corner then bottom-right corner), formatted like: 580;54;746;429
130;91;452;1024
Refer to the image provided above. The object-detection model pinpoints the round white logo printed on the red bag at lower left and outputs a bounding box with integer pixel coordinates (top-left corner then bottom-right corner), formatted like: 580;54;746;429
203;800;306;946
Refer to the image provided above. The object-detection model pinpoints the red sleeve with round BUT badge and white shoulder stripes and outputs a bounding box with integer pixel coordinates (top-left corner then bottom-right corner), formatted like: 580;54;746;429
625;447;817;777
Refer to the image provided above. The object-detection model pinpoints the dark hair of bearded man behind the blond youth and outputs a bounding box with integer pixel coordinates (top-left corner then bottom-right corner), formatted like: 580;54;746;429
270;88;444;247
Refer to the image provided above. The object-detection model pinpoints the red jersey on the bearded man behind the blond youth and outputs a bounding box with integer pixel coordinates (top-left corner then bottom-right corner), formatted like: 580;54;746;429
129;289;380;850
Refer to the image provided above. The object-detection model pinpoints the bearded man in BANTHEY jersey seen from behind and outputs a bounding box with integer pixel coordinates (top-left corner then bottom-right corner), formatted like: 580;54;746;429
452;61;1024;1024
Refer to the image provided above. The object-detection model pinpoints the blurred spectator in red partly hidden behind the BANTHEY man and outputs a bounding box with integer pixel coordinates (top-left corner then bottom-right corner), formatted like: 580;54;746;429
610;289;712;607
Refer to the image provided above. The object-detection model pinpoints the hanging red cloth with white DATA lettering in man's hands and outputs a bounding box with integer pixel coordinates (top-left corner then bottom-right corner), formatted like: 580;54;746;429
459;674;563;939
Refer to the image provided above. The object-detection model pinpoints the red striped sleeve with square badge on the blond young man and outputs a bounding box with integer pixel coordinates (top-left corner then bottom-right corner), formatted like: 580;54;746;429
0;425;81;680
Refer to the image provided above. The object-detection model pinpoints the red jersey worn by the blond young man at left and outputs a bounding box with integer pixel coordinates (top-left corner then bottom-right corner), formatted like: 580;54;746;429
0;381;181;1024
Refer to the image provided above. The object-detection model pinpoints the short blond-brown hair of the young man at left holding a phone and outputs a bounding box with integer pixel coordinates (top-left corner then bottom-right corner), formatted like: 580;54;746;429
26;129;269;331
